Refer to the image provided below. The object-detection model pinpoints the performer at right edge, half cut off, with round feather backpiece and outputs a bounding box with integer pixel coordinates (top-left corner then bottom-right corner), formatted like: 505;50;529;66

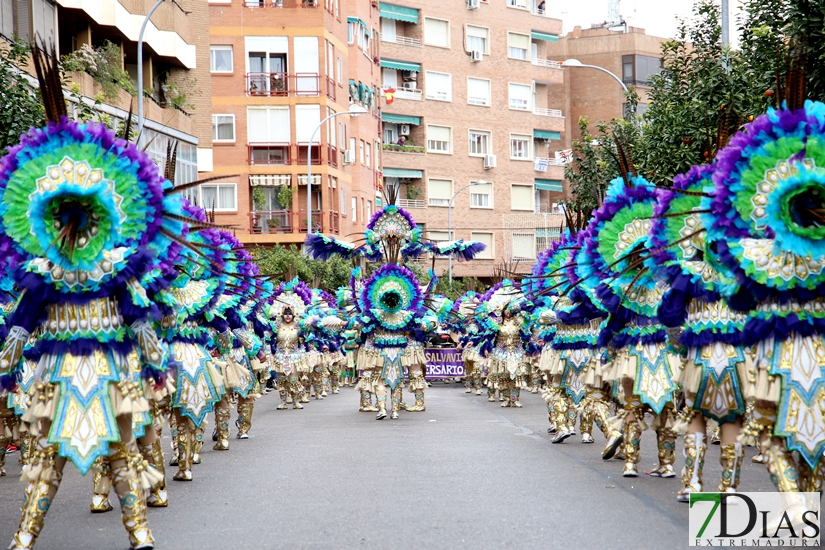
701;97;825;498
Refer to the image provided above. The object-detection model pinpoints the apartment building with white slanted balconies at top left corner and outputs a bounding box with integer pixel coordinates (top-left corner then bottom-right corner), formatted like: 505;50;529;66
0;0;212;182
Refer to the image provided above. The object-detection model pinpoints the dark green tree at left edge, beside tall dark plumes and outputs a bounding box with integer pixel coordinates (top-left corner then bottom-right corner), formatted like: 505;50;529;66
0;41;45;149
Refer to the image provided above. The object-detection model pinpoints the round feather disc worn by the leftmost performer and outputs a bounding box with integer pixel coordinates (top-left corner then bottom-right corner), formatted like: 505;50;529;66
0;117;184;293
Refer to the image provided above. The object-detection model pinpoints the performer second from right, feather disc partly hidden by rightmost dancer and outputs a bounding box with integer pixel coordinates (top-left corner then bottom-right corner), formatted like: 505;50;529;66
646;165;752;502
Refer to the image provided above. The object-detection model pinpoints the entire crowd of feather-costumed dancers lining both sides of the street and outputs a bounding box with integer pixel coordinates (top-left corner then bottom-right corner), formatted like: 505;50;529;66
0;42;825;550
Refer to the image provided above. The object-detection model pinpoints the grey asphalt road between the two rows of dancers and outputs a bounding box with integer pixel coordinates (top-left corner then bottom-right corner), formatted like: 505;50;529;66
0;382;772;550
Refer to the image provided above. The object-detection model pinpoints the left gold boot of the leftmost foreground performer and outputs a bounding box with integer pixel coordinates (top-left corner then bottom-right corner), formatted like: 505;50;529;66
8;444;62;550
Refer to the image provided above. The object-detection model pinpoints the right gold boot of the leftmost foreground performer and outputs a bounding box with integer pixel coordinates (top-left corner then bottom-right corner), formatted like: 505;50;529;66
109;441;154;550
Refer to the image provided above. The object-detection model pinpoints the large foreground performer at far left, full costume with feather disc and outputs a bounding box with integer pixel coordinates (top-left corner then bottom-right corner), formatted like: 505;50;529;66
0;48;203;549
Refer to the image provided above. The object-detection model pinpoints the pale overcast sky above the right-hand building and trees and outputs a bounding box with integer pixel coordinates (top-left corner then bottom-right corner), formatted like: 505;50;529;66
560;0;739;40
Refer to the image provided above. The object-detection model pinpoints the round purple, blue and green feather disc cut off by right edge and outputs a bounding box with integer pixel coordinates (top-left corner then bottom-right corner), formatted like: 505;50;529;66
704;101;825;300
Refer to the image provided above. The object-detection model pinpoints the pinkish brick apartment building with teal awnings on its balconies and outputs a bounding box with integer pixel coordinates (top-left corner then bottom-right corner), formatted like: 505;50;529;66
379;0;567;277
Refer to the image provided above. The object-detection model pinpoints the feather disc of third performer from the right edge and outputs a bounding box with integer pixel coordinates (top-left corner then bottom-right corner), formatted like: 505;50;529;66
576;176;664;317
